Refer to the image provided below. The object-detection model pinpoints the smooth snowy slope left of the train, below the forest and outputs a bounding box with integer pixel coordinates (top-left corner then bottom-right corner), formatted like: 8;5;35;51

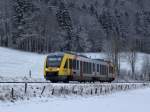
0;47;45;78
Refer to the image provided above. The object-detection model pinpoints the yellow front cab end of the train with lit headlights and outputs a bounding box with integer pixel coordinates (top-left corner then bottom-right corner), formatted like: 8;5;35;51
44;53;70;82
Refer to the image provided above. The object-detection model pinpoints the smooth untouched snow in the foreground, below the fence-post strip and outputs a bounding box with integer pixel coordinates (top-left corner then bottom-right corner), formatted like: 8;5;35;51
0;88;150;112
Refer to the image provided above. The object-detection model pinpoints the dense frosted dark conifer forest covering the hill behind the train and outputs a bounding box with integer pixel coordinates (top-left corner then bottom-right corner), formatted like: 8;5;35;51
0;0;150;53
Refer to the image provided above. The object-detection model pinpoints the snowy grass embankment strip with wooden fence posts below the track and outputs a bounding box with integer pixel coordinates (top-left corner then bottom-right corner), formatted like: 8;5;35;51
0;82;150;102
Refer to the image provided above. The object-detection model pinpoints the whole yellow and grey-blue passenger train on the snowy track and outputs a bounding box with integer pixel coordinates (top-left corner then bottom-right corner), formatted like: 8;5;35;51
44;52;115;82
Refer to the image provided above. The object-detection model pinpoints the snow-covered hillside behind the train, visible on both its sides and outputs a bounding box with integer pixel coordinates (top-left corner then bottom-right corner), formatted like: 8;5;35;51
0;47;149;79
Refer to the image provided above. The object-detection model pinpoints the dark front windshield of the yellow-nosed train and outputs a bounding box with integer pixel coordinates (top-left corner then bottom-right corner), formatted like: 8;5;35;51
47;56;62;67
